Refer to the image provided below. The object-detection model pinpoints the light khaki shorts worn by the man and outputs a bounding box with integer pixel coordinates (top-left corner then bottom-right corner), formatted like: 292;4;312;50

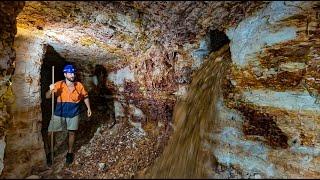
48;115;79;132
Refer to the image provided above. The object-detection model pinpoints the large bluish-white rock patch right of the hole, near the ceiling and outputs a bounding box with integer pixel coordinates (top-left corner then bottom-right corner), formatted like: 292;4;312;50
226;1;308;68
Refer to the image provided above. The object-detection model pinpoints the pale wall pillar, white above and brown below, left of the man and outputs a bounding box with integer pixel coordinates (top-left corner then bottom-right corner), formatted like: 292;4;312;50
3;27;46;178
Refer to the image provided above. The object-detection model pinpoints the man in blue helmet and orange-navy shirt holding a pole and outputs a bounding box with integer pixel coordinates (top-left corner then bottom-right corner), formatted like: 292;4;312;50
46;65;91;165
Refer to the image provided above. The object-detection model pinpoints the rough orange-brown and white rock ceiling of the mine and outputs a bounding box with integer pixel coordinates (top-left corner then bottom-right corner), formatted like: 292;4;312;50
17;1;267;62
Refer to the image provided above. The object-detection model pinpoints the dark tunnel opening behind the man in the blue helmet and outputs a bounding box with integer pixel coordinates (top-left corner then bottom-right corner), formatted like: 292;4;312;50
40;45;116;170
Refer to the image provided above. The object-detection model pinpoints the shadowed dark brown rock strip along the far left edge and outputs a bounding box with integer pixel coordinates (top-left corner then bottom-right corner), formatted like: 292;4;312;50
0;1;24;174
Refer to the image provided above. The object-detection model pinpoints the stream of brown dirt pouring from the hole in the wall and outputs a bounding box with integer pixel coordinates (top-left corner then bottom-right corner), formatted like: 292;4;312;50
146;45;230;178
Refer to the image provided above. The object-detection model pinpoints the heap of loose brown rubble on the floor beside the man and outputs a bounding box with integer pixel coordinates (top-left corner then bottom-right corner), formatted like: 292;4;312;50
28;108;168;179
